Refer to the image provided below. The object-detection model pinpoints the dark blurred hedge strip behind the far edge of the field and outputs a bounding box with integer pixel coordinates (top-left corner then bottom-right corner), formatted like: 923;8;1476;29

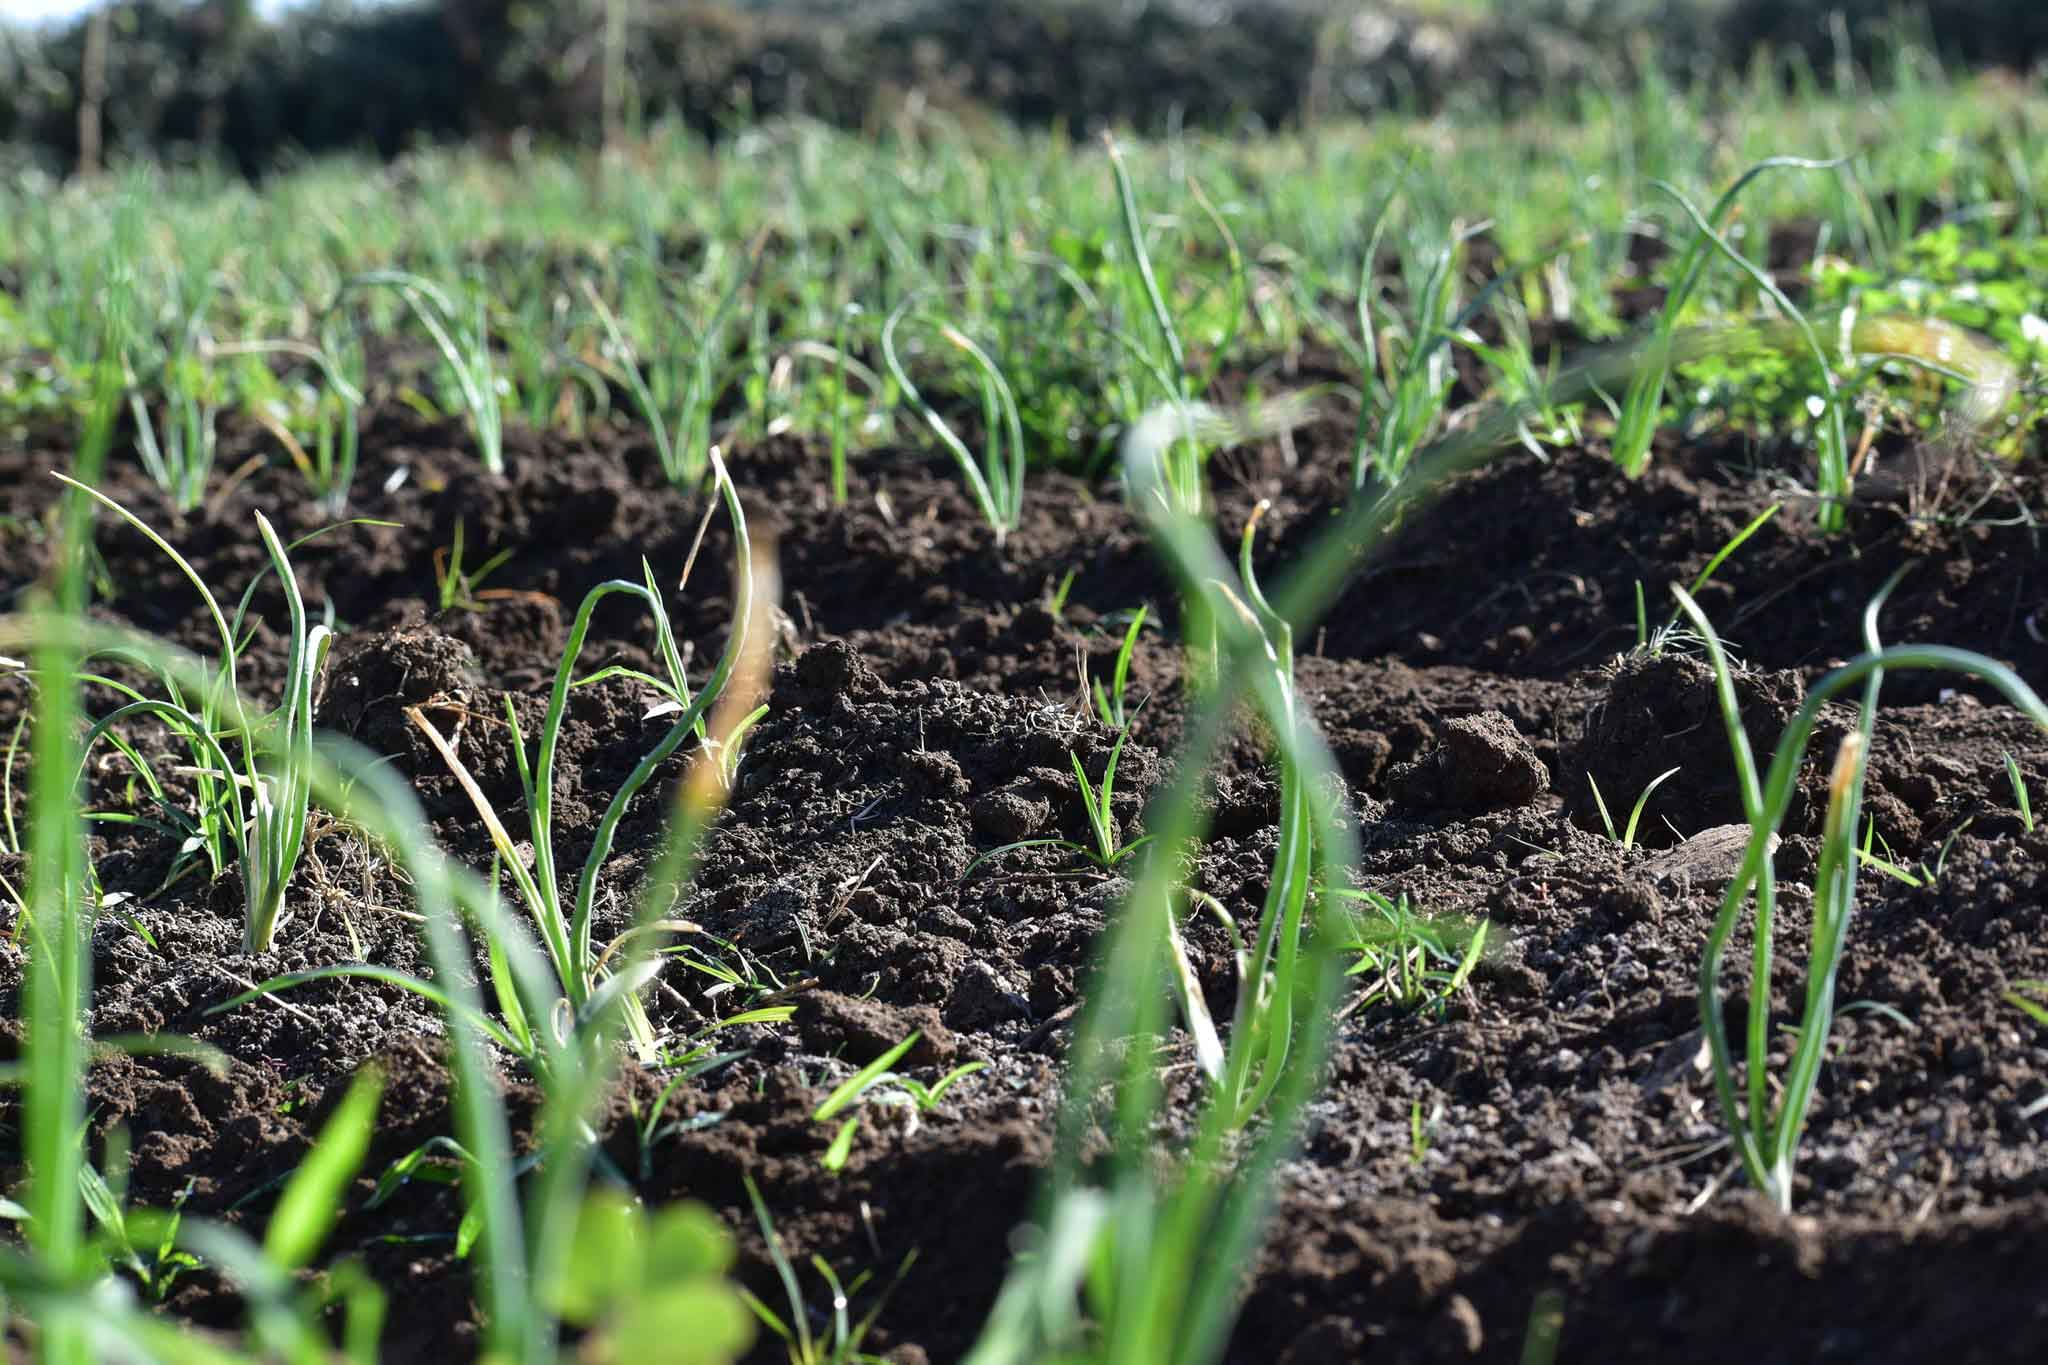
0;0;2048;174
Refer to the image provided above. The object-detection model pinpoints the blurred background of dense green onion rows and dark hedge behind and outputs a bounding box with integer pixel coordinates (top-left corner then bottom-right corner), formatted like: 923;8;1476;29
0;0;2048;471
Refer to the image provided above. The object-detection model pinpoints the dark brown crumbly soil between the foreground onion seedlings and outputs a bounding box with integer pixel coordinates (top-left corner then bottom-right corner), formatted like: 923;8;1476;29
0;407;2048;1365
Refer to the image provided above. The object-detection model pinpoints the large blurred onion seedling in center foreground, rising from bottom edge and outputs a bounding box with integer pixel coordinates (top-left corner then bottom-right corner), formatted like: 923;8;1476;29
969;405;1356;1365
